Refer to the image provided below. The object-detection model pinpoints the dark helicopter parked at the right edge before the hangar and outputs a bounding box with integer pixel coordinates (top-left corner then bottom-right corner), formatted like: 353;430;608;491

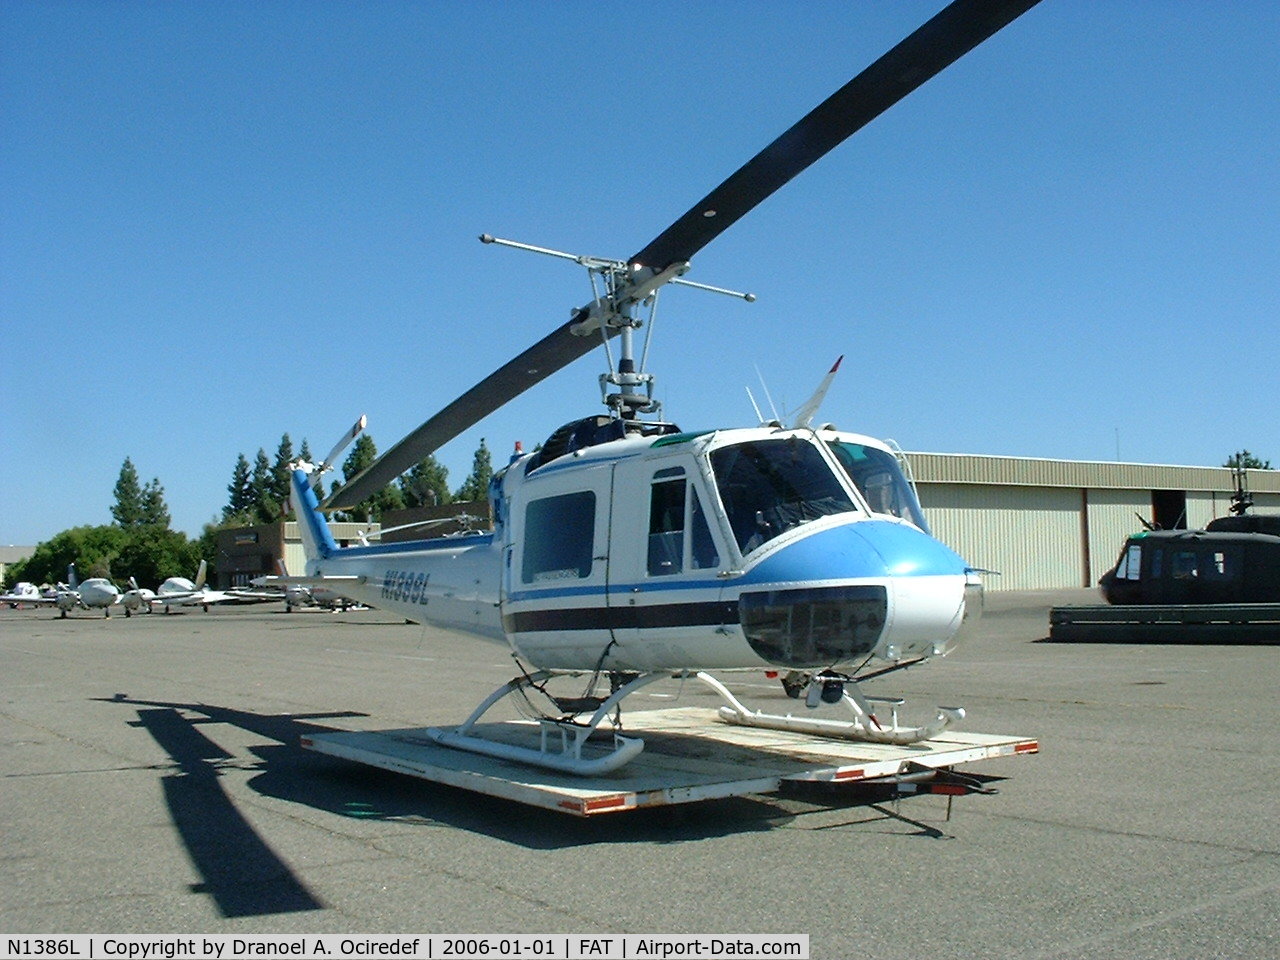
1098;466;1280;605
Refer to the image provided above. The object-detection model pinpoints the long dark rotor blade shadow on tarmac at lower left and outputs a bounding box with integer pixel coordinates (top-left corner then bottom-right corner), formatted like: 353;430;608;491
138;709;324;916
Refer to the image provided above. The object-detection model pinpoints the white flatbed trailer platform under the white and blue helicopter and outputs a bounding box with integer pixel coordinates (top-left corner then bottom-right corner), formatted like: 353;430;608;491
302;708;1039;817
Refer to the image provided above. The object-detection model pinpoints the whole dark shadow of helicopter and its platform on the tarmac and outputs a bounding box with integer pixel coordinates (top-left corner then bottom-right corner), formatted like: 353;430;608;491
100;694;849;890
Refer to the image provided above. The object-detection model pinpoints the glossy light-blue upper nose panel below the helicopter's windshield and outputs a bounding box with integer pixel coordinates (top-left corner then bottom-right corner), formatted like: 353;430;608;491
735;520;966;584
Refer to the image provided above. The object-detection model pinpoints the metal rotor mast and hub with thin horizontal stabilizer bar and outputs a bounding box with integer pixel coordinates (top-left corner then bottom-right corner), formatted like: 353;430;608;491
480;233;755;420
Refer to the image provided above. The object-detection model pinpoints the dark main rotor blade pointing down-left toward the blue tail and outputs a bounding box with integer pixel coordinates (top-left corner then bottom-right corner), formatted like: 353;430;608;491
321;320;600;511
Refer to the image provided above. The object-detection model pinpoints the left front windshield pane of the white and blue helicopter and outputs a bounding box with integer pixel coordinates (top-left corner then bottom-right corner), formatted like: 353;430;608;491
710;436;856;554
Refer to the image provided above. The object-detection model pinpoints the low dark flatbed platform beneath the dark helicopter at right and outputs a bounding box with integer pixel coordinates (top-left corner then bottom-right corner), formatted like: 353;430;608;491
1048;603;1280;644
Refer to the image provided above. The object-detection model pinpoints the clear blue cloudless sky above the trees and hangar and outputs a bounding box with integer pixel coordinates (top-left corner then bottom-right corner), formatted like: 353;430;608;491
0;0;1280;544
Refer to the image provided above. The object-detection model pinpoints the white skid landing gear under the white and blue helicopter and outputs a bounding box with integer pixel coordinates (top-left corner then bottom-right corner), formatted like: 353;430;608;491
426;671;965;777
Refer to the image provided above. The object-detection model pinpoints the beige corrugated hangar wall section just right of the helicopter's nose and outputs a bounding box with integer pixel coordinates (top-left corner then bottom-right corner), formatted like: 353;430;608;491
919;484;1085;590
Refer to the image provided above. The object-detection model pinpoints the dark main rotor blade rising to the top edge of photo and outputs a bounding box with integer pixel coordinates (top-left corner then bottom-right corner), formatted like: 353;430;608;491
631;0;1039;270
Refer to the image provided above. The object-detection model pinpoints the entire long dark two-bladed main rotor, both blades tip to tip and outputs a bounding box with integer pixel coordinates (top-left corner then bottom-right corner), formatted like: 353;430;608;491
321;0;1039;511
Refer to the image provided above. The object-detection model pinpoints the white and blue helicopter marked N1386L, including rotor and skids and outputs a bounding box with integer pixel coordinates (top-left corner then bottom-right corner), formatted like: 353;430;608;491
270;0;1036;776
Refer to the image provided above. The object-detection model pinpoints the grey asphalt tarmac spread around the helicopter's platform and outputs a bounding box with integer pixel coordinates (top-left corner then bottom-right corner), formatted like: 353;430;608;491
0;591;1280;960
